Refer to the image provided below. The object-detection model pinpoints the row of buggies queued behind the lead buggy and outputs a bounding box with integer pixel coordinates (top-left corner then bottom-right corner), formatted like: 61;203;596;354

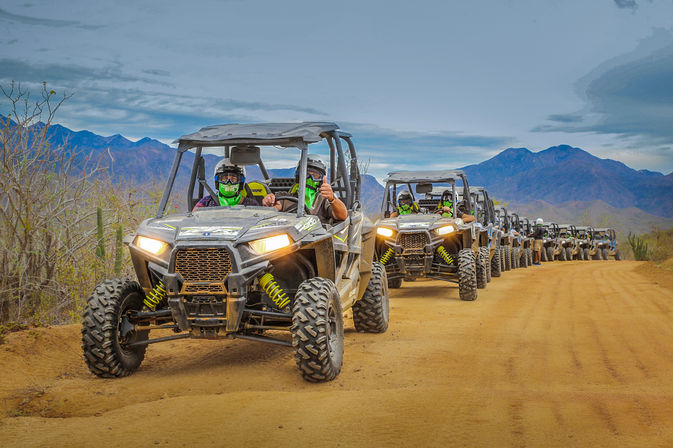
376;170;621;300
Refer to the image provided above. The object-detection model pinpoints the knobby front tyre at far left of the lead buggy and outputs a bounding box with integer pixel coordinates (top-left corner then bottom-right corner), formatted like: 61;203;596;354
82;278;149;378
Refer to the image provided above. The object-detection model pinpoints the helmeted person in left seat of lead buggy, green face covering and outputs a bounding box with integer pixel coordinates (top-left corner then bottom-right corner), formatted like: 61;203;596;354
192;159;259;211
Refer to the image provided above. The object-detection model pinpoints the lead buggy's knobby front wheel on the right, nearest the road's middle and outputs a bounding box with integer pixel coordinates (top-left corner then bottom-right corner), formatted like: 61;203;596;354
290;277;344;383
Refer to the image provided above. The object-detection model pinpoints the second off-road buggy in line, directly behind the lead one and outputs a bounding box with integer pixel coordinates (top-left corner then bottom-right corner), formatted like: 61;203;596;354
376;170;489;300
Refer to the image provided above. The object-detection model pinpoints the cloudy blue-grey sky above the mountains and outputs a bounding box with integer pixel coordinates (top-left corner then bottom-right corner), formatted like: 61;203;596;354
0;0;673;177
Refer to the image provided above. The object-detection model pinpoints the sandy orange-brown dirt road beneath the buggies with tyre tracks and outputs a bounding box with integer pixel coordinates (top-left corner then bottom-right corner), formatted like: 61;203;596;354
0;261;673;447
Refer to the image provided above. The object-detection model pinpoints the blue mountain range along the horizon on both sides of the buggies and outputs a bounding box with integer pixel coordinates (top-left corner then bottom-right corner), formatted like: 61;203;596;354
13;120;673;222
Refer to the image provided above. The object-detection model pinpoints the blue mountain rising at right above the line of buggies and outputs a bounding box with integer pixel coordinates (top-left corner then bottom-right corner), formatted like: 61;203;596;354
463;145;673;217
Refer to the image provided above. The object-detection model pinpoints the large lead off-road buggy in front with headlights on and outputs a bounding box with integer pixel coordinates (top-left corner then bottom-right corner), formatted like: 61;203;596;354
82;122;388;381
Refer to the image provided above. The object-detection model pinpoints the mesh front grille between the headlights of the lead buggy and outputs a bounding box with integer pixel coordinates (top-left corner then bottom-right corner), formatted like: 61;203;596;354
175;249;232;294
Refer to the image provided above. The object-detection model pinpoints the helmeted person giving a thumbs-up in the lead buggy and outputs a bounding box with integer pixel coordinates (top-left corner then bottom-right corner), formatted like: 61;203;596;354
262;154;348;224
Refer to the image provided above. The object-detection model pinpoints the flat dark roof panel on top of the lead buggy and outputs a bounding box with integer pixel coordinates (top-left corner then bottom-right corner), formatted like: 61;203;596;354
173;121;351;149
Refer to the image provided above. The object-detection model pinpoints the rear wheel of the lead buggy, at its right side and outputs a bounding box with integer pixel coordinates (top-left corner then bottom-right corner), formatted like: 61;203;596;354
353;262;390;333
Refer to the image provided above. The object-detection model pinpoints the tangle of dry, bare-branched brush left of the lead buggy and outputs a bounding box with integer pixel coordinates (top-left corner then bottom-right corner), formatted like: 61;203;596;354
0;83;160;324
